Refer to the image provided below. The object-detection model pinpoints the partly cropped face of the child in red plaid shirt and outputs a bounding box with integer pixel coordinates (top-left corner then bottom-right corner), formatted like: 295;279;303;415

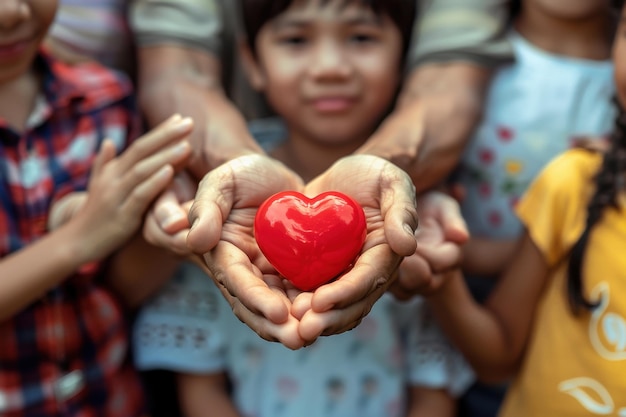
0;0;57;84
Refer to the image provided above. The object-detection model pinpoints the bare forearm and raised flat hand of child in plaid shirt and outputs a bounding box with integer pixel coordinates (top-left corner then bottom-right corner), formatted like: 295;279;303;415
0;118;191;320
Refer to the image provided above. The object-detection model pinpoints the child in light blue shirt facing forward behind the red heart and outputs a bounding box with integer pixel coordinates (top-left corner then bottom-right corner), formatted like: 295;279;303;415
134;0;472;417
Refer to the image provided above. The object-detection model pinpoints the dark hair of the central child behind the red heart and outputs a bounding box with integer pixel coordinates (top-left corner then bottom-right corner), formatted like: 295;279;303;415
239;0;417;56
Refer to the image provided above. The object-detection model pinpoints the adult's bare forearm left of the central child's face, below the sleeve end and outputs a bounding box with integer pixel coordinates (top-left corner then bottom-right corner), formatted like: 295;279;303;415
138;44;263;178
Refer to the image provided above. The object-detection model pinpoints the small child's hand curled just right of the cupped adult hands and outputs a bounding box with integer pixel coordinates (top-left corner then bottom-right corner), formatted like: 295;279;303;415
390;191;469;300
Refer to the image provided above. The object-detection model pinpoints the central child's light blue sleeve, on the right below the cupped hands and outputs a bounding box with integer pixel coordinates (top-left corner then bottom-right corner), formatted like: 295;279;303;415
407;300;475;398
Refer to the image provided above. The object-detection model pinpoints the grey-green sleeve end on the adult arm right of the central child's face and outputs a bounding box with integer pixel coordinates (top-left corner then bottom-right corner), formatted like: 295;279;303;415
409;0;513;68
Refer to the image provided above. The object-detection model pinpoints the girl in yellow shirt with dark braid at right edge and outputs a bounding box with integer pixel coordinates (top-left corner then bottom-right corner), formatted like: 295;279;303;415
420;2;626;417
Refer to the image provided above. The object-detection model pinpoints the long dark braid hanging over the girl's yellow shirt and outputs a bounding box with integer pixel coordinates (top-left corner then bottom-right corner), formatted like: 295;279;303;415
567;100;626;314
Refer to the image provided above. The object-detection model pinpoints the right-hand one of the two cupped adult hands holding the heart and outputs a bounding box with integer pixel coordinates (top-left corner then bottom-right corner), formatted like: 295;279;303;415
292;155;417;343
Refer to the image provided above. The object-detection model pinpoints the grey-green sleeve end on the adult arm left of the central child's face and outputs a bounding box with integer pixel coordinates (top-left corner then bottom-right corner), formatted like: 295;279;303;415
128;0;224;55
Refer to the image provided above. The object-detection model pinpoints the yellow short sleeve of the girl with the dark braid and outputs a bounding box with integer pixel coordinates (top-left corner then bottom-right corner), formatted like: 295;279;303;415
515;149;602;266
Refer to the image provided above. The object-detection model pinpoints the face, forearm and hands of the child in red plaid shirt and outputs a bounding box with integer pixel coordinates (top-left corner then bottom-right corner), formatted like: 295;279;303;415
0;0;192;320
